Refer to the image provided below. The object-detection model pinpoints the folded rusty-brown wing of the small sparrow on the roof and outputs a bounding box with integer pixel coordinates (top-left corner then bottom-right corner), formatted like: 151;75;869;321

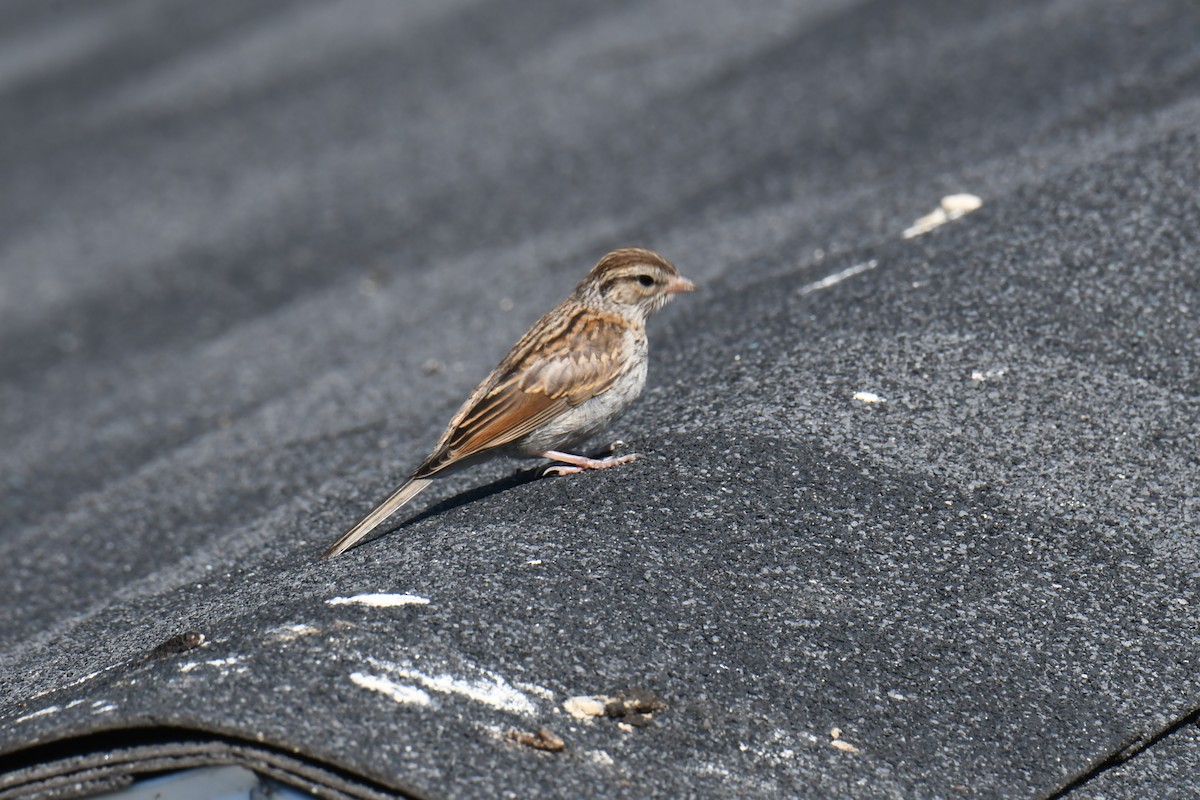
413;303;629;479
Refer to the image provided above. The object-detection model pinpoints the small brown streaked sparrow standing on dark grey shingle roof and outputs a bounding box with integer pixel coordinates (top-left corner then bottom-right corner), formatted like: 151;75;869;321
322;247;696;559
